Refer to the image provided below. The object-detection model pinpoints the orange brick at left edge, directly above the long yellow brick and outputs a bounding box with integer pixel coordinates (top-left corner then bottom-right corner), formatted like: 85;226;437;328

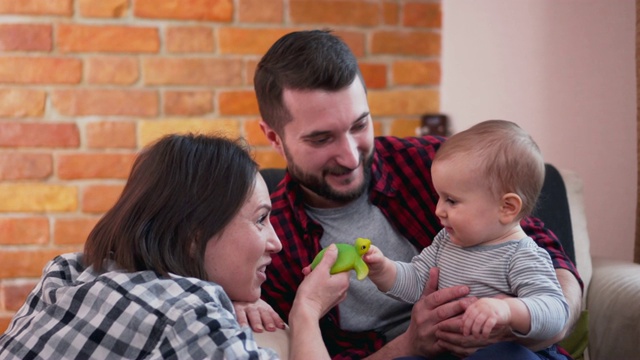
0;151;53;180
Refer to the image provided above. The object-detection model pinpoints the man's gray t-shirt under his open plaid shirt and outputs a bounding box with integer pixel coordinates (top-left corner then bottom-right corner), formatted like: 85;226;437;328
306;193;418;340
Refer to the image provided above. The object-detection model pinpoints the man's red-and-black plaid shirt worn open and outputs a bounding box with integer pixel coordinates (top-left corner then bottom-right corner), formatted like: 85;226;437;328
262;136;582;359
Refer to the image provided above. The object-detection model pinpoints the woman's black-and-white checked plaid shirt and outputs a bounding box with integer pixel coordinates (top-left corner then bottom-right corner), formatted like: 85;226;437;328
0;254;277;359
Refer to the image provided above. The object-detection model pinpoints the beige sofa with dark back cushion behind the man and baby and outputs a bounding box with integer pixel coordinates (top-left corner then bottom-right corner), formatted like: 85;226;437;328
256;164;640;360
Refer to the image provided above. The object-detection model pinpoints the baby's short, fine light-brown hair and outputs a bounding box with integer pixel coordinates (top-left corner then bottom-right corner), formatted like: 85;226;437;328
433;120;545;218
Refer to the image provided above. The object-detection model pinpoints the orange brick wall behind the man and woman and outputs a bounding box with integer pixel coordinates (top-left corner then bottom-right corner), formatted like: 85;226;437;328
0;0;441;331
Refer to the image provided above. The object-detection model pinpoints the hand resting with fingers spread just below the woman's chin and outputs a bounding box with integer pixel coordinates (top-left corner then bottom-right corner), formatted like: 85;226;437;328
233;299;285;332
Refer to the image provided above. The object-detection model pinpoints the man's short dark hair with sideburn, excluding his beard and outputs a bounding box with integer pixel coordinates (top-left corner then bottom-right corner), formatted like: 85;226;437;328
253;30;366;135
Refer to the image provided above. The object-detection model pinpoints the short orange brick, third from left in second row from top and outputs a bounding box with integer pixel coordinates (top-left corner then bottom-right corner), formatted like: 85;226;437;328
165;26;214;53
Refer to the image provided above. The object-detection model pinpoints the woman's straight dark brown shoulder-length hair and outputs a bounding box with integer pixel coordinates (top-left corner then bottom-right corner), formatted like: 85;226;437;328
84;135;258;280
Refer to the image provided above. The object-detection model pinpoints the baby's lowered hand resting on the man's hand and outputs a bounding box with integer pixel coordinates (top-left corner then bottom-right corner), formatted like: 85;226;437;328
462;298;511;339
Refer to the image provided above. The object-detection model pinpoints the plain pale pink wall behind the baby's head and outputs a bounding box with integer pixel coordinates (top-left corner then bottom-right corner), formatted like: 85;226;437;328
441;0;637;260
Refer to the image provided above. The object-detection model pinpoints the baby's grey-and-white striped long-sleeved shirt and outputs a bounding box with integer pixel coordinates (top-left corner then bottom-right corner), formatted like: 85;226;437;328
388;230;569;340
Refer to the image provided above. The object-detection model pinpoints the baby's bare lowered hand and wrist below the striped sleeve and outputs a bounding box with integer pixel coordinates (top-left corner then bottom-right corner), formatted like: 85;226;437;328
462;298;531;339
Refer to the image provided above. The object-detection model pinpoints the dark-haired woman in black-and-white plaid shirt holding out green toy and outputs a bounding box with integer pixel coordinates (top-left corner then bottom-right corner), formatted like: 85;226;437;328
0;135;348;359
